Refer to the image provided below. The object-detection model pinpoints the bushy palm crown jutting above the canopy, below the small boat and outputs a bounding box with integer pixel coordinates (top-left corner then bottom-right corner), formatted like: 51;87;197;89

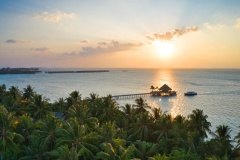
188;109;211;137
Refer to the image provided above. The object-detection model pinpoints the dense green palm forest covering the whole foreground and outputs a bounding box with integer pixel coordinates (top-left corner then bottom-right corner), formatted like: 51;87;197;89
0;84;240;160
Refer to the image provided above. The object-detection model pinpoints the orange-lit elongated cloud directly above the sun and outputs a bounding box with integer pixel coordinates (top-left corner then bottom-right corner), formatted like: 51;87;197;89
146;26;199;41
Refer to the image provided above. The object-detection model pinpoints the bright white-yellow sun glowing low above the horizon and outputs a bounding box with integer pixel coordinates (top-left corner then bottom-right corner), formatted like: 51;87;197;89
153;41;174;57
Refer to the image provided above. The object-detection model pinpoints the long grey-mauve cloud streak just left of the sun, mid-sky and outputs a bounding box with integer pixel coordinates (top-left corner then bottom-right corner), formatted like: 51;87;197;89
79;40;143;55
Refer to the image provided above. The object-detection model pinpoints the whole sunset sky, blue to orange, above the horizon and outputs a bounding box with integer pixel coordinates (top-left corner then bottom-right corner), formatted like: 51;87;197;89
0;0;240;68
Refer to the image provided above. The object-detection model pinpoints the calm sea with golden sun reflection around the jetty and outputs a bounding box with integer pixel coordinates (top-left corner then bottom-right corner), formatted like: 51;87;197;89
0;69;240;136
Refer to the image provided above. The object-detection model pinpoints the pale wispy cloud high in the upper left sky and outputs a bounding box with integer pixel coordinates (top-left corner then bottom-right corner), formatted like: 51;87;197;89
34;11;75;22
